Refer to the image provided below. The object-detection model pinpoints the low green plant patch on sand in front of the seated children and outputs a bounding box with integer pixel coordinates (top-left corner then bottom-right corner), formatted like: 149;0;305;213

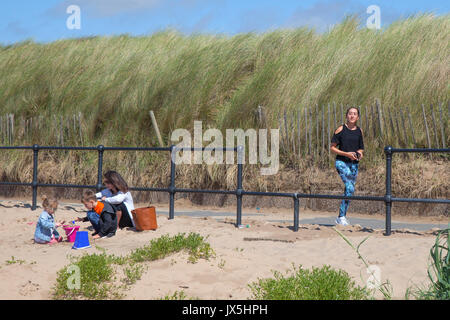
52;233;214;300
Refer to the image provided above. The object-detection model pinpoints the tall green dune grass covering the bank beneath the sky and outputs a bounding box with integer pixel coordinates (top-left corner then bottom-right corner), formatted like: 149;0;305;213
0;14;450;200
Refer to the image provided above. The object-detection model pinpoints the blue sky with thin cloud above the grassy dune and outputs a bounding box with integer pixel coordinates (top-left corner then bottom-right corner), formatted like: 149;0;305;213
0;0;450;44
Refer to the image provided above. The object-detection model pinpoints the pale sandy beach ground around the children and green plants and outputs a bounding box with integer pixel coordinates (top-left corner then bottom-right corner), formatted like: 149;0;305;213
0;199;448;300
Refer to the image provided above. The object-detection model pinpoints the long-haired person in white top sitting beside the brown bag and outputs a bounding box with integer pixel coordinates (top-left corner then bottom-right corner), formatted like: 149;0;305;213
96;171;135;229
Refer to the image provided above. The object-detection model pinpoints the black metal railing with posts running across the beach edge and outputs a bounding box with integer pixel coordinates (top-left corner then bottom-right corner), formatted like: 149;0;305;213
0;144;450;236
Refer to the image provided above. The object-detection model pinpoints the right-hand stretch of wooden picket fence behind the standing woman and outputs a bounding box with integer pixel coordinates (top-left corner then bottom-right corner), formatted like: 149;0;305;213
268;100;450;162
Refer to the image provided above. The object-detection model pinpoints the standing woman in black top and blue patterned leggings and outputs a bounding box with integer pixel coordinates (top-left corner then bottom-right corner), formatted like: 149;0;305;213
330;107;364;226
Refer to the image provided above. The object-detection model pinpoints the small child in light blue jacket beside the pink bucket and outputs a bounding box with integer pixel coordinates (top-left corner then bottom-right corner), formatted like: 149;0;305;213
34;196;65;244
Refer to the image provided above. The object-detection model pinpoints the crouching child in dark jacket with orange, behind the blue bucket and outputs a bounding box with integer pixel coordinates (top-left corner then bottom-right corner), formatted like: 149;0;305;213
76;190;117;239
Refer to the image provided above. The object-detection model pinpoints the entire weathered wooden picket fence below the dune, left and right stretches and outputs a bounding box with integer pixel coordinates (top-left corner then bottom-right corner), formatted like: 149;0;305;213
0;100;450;163
